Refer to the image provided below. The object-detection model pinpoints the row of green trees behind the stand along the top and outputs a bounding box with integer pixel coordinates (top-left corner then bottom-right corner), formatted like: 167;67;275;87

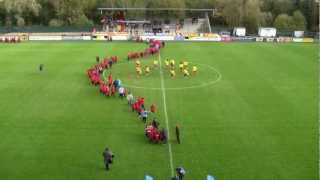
0;0;319;32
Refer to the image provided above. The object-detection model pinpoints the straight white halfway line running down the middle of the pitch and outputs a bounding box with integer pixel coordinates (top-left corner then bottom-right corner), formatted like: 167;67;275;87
158;52;174;176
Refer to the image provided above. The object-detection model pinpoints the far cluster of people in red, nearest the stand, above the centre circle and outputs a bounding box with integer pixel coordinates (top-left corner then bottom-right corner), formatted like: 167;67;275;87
128;39;165;60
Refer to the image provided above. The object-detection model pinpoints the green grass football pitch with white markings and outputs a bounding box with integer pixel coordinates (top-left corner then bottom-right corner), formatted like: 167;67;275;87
0;42;319;180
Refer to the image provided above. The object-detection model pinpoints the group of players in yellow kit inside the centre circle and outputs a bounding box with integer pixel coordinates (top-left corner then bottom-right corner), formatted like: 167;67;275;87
135;59;198;78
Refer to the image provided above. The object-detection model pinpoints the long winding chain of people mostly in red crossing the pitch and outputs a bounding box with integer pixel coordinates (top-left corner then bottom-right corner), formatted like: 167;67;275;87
87;40;167;143
